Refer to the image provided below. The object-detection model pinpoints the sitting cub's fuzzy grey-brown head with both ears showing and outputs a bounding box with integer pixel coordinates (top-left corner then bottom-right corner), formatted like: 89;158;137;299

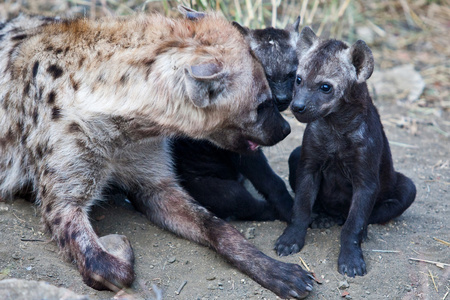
291;27;374;123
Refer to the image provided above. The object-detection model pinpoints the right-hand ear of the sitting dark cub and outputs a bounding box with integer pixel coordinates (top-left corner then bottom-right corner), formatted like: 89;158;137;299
350;40;374;83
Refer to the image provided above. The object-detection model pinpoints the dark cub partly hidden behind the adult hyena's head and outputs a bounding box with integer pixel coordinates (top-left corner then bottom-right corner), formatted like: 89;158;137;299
173;11;300;221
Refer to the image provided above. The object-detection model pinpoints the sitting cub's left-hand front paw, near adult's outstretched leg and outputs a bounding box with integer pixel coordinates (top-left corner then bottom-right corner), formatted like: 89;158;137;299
275;225;305;256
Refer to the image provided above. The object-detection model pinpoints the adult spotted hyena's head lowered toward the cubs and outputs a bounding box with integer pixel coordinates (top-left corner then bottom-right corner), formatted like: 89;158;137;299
179;6;290;152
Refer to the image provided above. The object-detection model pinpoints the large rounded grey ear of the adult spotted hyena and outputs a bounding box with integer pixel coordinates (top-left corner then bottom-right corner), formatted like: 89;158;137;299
184;63;227;108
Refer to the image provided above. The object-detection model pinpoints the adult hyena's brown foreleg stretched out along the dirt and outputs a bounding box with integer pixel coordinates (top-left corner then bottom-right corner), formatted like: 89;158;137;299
129;178;312;298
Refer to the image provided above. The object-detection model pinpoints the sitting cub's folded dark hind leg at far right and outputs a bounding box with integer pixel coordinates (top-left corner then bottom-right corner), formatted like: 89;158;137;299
369;172;416;224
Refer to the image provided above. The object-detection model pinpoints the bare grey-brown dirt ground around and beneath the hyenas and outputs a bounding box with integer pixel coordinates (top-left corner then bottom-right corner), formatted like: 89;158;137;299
0;2;450;300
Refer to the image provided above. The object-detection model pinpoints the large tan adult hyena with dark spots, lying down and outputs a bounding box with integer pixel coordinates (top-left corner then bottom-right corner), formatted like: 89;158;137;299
0;8;311;297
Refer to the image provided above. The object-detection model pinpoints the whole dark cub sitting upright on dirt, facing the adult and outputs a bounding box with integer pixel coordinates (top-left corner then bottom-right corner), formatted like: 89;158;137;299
276;28;416;277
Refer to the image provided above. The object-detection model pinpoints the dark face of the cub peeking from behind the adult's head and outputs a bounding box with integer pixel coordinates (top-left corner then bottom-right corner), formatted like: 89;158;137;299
232;17;300;111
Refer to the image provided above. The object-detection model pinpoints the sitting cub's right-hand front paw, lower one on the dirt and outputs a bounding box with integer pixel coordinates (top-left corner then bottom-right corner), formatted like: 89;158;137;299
338;248;367;277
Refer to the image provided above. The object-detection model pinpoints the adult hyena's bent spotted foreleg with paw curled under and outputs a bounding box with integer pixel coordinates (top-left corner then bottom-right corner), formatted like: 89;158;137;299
38;172;134;290
